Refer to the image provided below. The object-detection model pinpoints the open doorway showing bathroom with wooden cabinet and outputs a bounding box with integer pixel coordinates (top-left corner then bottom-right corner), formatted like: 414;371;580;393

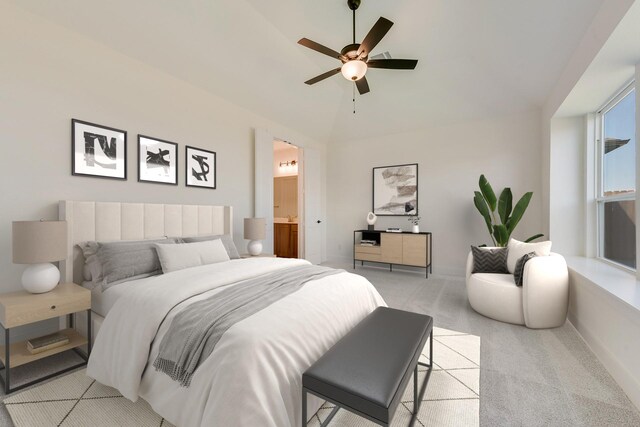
273;139;302;258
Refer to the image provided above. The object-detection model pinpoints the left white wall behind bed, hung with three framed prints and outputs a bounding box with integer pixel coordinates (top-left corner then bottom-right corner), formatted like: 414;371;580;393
0;2;324;298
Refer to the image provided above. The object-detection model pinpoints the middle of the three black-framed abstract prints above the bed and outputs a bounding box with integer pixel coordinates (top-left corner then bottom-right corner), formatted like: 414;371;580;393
138;134;178;185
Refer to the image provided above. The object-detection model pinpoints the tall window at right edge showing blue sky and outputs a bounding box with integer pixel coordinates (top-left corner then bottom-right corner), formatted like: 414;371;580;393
597;84;636;269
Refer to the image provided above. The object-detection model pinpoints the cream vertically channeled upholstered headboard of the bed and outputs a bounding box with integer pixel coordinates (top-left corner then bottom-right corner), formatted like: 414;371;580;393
59;200;233;284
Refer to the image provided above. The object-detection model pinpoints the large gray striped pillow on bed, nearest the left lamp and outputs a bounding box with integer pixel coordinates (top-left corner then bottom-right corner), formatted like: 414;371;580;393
79;239;177;291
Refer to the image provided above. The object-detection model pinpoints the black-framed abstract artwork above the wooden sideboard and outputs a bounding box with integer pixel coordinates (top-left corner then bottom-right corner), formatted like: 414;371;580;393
371;163;419;216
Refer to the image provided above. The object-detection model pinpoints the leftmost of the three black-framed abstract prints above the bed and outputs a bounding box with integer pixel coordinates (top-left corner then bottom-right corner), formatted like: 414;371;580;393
71;119;127;180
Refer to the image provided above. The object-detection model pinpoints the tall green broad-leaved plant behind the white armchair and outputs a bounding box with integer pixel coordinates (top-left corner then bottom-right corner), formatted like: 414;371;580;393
473;175;544;247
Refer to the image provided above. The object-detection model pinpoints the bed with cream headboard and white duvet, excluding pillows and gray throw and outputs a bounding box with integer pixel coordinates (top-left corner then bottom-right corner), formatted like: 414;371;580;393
60;201;385;427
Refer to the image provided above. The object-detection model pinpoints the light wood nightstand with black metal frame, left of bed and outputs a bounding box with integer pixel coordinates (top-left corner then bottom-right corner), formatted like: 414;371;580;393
0;283;91;394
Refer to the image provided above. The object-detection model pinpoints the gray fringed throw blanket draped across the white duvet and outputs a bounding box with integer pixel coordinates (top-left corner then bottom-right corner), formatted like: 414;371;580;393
153;265;344;387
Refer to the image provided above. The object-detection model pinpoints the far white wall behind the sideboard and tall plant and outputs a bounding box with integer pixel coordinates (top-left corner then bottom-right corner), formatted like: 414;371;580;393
327;111;542;275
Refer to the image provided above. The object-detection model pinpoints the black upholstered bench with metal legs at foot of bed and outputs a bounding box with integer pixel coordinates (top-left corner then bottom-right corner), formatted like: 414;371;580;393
302;307;433;426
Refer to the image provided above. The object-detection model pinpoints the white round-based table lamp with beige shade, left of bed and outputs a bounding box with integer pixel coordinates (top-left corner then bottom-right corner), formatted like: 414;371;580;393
13;220;67;294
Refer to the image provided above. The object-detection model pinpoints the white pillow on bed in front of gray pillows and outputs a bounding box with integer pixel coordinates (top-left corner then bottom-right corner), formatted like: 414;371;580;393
156;240;230;273
